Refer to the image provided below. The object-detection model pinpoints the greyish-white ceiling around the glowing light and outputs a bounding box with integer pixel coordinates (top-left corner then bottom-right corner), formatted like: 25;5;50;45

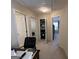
17;0;67;13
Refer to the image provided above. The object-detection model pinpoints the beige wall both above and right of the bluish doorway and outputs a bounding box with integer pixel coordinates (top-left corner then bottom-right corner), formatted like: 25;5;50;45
52;6;68;55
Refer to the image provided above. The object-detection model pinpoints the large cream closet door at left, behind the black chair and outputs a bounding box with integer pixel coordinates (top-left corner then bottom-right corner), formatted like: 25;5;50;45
15;12;26;46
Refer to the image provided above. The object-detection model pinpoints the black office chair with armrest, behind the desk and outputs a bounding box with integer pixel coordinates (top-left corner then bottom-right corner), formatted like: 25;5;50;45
16;37;36;51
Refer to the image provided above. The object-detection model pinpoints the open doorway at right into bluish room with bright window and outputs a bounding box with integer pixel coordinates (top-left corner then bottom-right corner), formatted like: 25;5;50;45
52;16;60;45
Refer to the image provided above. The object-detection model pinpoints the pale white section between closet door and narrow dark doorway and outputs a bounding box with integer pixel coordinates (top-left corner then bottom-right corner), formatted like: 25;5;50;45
26;16;36;36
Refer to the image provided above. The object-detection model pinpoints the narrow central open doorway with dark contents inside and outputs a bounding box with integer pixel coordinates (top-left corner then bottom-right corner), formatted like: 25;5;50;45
40;18;47;41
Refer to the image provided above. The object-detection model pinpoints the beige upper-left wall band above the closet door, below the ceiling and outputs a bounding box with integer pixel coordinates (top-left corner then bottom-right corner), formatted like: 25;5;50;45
12;0;36;16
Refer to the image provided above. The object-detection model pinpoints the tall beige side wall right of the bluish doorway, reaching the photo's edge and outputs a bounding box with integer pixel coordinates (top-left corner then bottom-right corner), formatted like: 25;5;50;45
60;7;68;56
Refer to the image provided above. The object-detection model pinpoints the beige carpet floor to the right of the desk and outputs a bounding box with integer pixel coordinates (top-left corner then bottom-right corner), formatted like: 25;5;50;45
37;41;67;59
